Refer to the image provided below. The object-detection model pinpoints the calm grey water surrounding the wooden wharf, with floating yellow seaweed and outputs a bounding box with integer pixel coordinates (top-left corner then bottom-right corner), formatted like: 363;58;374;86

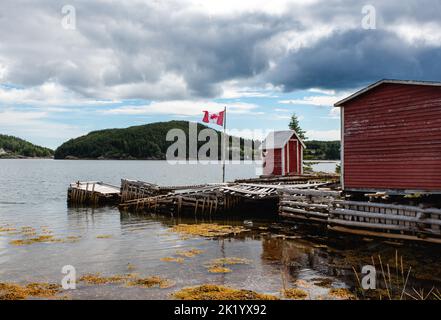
0;160;441;299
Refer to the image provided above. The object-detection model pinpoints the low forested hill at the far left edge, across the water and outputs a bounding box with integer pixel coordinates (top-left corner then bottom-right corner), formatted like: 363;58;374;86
0;134;54;158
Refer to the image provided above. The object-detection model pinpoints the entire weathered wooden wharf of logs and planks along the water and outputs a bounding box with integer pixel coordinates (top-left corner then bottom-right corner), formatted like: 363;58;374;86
68;175;441;244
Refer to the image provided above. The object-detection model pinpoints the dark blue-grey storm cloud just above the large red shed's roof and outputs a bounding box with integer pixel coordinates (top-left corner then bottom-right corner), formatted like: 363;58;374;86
268;30;441;91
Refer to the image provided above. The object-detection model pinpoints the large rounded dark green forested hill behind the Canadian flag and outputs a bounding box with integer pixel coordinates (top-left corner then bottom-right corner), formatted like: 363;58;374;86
55;121;256;160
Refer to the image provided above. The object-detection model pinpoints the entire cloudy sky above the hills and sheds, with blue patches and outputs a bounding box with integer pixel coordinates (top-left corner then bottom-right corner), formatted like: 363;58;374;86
0;0;441;148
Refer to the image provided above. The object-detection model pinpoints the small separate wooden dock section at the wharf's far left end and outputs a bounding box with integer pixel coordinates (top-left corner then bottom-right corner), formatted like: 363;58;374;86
67;181;120;205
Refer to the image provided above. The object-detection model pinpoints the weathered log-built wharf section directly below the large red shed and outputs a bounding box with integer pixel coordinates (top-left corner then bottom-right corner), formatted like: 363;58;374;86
279;188;441;244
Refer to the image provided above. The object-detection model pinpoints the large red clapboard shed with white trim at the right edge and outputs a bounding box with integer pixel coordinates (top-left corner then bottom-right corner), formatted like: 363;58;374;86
335;80;441;194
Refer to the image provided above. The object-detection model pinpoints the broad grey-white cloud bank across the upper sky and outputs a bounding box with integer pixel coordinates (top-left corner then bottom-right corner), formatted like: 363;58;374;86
0;0;441;100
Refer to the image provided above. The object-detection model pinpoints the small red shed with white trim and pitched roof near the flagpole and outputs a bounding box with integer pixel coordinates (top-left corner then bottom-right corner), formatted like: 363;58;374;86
262;130;306;176
